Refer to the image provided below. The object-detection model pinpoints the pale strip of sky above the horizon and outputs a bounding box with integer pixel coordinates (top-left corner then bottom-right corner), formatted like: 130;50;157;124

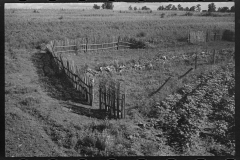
5;2;234;10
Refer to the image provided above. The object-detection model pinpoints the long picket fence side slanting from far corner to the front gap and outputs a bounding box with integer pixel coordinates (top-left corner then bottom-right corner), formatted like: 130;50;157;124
47;41;93;105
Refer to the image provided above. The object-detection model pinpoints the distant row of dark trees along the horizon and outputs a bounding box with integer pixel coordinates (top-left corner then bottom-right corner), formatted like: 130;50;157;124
93;2;235;12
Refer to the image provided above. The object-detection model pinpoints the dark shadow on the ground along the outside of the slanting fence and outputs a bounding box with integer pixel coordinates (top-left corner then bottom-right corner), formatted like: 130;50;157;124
31;51;108;119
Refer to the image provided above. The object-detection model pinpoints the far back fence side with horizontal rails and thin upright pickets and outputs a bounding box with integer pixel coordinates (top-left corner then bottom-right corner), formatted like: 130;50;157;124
55;36;132;53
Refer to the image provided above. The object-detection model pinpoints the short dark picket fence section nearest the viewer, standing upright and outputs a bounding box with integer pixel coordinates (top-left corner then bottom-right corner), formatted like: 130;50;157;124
99;81;125;118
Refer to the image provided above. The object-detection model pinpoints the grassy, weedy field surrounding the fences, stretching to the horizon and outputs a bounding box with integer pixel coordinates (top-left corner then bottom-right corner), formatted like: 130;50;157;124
5;9;235;157
